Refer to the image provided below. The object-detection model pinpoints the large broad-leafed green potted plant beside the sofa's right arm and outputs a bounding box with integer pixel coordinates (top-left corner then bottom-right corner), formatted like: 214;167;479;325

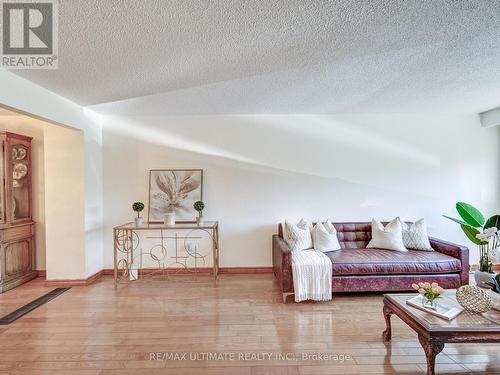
443;202;500;288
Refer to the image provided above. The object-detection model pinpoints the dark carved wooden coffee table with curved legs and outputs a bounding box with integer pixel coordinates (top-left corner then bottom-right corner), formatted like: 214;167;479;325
383;290;500;375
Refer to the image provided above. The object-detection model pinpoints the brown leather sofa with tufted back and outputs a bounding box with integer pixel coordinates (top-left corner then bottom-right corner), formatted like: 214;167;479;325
273;223;469;303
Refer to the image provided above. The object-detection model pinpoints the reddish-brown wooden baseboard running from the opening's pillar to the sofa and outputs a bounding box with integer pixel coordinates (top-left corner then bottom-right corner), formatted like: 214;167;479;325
38;267;273;287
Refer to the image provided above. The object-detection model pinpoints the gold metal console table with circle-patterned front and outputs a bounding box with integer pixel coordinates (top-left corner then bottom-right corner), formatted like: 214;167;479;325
113;221;219;289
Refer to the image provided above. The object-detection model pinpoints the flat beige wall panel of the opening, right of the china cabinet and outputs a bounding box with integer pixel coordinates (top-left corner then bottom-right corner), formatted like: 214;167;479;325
44;125;87;280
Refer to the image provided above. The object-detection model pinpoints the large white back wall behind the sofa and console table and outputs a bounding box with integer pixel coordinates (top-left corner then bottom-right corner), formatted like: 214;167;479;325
103;114;500;268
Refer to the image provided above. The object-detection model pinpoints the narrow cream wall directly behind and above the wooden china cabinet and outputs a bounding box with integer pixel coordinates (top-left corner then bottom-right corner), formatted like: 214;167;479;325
0;116;45;270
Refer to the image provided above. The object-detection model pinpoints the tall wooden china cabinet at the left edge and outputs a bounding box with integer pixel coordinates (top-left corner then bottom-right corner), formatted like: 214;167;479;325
0;132;37;293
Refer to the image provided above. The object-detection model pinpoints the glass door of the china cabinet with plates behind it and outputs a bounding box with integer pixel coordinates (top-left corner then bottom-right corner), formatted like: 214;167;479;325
10;144;31;220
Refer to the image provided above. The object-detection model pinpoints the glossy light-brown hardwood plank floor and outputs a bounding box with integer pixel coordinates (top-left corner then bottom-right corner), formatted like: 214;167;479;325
0;274;500;375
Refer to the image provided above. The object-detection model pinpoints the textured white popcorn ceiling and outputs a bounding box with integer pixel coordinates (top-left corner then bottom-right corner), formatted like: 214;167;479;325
9;0;500;114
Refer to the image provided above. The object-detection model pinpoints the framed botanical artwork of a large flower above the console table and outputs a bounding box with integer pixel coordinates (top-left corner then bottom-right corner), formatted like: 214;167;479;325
148;169;203;223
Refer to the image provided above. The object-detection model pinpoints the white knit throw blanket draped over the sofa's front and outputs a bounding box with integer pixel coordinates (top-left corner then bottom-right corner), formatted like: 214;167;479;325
292;250;332;302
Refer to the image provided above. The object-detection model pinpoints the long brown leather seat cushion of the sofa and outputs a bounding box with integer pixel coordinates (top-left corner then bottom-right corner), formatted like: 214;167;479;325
325;249;462;275
